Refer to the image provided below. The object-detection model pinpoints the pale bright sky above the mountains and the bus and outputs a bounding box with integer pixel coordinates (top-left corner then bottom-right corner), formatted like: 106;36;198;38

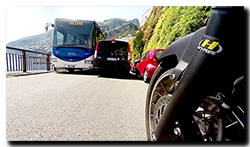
6;6;151;43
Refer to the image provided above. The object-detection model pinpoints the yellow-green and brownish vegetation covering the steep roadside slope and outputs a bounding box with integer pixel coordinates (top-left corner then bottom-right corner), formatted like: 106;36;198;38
129;6;211;60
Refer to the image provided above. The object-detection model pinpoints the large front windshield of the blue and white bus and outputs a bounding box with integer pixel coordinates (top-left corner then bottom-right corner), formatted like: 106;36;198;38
53;20;94;49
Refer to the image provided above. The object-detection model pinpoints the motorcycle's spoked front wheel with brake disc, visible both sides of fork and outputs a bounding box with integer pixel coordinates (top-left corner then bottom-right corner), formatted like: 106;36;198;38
145;64;242;141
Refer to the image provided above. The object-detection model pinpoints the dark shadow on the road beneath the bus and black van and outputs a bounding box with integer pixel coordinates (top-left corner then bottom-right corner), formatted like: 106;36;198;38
56;69;142;80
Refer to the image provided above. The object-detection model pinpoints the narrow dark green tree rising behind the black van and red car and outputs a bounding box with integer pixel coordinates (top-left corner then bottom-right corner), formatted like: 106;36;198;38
133;31;145;59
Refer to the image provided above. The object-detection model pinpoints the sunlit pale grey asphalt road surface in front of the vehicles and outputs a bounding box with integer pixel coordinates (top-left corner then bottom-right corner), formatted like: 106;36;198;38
6;71;148;141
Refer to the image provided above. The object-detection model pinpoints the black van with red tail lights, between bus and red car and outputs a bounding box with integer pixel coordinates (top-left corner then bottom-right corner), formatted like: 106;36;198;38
94;39;130;74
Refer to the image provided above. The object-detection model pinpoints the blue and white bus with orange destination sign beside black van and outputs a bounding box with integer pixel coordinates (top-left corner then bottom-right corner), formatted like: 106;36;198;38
45;18;105;71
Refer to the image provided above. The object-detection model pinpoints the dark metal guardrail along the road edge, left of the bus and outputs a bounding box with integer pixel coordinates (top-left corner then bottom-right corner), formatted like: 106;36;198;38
5;46;53;72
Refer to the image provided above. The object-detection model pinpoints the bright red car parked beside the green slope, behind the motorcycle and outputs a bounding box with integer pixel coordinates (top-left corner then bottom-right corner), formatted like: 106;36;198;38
131;49;164;83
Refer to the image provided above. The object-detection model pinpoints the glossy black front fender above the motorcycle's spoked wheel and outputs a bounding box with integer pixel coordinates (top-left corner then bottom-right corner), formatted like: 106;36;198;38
157;27;206;79
